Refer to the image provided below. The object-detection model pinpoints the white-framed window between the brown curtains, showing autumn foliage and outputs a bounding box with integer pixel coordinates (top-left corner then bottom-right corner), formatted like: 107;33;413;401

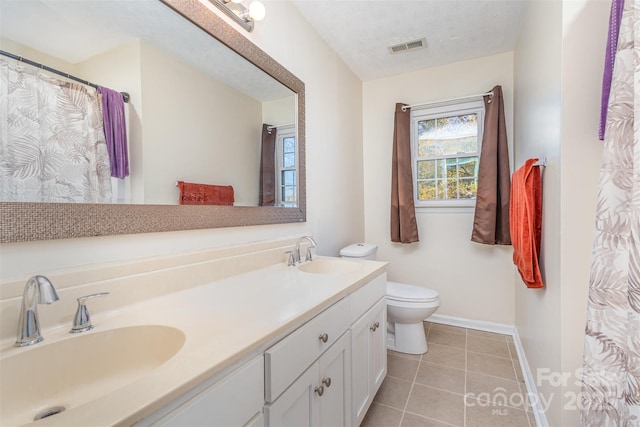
411;99;484;207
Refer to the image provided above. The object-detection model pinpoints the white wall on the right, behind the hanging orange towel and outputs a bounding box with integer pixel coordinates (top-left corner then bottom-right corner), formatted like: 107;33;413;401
515;0;610;426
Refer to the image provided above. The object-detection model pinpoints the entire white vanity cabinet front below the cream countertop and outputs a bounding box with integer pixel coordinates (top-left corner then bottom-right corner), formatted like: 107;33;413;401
138;266;387;427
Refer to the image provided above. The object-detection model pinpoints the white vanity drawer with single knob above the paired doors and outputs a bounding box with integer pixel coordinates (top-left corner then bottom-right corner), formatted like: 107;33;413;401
265;297;350;402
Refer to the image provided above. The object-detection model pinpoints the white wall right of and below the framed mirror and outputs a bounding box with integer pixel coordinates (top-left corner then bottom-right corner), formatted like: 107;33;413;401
0;1;364;281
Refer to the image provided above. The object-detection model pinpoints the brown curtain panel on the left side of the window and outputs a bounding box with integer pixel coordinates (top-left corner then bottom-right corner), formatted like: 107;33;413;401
391;103;419;243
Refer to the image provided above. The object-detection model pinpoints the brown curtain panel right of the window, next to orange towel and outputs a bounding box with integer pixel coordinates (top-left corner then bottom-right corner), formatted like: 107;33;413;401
471;86;511;245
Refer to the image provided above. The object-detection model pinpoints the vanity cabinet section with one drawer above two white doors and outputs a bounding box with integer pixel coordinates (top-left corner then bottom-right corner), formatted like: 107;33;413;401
264;297;351;427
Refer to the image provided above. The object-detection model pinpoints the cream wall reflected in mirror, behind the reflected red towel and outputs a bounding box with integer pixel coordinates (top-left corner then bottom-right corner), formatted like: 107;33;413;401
140;43;262;206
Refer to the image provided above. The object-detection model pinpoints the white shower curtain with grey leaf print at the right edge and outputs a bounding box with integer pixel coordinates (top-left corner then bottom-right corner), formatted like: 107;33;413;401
581;0;640;427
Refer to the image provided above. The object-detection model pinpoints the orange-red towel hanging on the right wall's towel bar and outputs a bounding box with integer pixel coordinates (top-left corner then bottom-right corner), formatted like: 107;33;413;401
509;159;544;288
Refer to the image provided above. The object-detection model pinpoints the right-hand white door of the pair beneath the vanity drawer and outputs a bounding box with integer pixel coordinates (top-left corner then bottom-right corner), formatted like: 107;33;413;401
318;331;351;427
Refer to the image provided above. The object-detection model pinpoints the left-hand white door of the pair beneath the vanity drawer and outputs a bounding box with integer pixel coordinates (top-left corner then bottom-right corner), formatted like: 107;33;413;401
265;362;320;427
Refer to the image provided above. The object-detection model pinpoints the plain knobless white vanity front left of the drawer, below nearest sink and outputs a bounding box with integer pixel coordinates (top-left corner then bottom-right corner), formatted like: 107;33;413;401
144;355;264;427
